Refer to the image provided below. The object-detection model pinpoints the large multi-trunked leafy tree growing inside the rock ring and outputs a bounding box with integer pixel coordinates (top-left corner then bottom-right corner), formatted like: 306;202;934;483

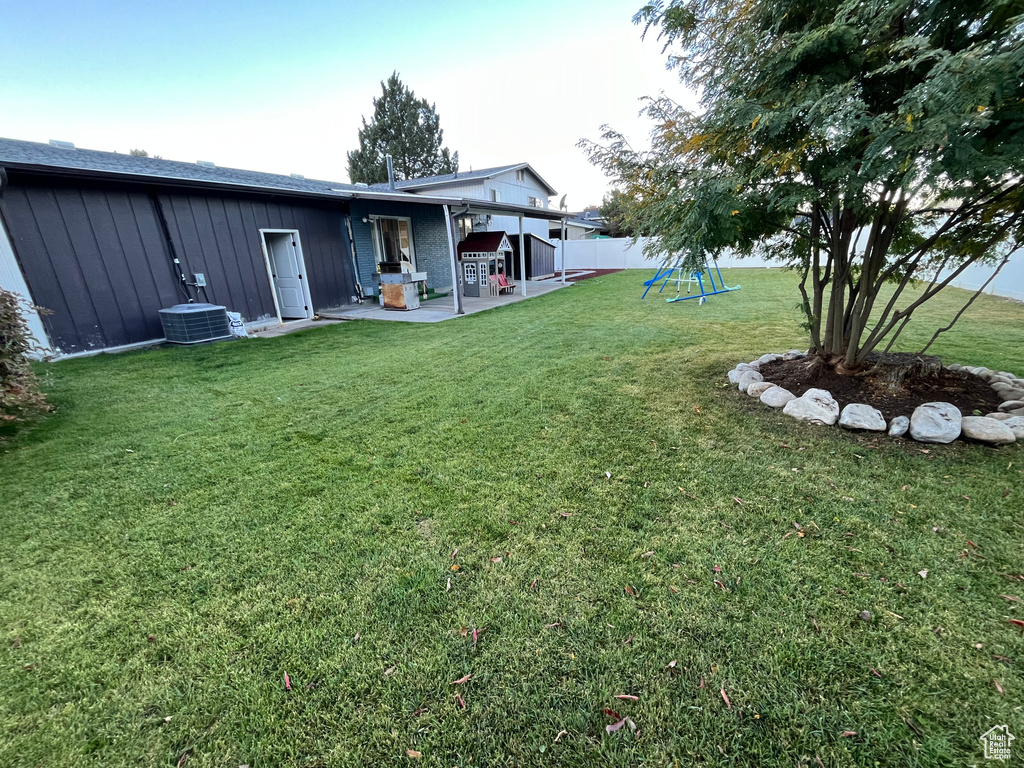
583;0;1024;373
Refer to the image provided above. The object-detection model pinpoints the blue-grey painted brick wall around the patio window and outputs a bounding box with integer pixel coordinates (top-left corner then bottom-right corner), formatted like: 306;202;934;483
350;200;452;293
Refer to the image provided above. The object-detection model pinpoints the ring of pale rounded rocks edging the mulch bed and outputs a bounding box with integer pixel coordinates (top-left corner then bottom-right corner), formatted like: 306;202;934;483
728;349;1024;445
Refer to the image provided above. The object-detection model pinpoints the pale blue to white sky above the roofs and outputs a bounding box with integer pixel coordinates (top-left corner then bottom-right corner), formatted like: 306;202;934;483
0;0;691;208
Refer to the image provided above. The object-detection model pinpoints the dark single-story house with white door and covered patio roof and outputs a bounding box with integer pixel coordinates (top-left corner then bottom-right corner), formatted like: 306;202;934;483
0;139;564;355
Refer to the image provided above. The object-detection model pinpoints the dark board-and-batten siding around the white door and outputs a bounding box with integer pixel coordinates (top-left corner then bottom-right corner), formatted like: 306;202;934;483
0;178;354;353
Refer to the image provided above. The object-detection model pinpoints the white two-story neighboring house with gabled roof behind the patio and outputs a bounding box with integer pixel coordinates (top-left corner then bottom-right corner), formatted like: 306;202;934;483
373;163;557;240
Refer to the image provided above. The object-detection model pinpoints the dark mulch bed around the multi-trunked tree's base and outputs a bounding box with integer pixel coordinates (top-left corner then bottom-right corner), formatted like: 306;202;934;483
761;359;1000;421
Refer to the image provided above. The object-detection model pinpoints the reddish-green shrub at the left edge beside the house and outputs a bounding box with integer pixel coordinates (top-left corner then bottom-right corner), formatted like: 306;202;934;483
0;288;50;421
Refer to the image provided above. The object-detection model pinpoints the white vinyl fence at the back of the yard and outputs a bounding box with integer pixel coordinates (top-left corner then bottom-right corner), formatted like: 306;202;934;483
556;238;1024;301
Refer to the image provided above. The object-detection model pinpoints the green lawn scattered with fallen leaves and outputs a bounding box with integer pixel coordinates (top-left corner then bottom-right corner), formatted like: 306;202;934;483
0;270;1024;768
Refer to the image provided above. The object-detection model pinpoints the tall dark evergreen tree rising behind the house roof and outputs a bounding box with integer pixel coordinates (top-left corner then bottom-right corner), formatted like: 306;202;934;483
348;72;459;184
